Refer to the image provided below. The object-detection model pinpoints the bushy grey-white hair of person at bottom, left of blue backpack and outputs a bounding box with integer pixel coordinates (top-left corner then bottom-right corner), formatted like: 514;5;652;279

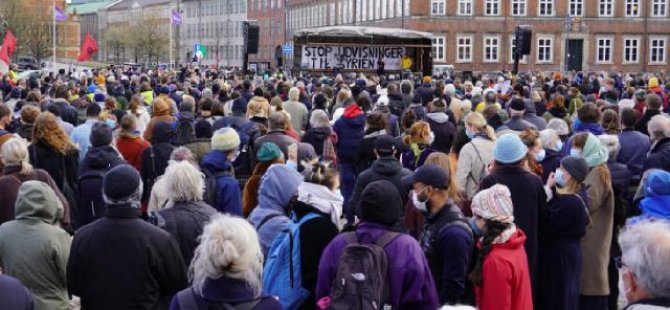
188;214;263;296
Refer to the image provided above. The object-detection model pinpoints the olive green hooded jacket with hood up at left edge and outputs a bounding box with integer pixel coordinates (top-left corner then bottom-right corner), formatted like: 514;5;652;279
0;181;70;310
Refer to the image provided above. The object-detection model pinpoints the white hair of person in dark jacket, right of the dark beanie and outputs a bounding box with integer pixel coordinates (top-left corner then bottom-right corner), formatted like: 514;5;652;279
164;161;205;202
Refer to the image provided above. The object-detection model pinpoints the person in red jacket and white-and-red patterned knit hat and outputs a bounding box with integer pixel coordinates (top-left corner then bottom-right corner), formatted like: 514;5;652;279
470;184;533;310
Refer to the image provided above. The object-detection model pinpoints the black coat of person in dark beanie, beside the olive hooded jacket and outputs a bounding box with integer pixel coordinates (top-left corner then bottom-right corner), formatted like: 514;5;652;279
67;206;187;310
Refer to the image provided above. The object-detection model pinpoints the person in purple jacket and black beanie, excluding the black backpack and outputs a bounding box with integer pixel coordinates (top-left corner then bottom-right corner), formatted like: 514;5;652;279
316;180;439;309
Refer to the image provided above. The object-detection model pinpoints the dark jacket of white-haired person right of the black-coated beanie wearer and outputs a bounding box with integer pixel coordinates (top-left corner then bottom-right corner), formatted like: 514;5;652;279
149;201;217;264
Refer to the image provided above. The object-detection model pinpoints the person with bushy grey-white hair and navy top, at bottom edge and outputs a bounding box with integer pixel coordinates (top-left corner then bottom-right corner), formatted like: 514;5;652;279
170;214;282;310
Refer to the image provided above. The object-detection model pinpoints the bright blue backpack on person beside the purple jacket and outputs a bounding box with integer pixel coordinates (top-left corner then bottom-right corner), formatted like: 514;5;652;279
259;213;319;310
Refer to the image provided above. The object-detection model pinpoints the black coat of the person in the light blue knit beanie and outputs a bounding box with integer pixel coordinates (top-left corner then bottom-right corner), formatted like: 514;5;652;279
479;166;547;291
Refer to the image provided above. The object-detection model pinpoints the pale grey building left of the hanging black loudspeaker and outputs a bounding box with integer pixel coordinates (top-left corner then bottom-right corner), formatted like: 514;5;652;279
177;0;247;67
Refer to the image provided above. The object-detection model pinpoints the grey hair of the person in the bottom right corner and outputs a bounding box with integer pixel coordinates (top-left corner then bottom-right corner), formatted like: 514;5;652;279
619;220;670;298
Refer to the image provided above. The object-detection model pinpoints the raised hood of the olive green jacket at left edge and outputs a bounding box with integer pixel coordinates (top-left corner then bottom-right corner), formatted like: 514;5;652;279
14;181;63;224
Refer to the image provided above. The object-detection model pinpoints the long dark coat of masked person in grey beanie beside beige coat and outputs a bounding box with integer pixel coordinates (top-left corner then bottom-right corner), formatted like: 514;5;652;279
538;195;589;310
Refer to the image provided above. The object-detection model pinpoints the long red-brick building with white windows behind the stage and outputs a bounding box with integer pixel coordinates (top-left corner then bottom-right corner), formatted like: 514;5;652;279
253;0;670;72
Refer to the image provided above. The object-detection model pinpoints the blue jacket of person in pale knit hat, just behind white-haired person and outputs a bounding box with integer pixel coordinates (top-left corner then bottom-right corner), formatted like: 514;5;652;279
201;151;242;216
